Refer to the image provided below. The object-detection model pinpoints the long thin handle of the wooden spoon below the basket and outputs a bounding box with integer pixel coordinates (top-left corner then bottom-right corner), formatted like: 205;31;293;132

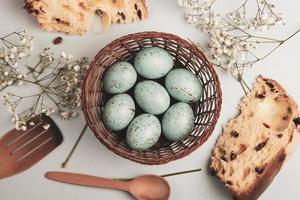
45;172;130;191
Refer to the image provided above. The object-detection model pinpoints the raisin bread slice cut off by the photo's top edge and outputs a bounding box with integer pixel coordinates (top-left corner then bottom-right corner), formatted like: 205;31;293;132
24;0;148;34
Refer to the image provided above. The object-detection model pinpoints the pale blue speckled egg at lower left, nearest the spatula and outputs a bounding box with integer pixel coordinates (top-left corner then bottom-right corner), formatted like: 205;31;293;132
102;94;135;131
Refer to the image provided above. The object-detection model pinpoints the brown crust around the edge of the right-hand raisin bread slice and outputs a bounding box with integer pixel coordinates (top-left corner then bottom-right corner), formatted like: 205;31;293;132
211;76;300;200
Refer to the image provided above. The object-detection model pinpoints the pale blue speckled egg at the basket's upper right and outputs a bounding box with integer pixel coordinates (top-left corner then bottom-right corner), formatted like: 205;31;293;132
165;68;203;102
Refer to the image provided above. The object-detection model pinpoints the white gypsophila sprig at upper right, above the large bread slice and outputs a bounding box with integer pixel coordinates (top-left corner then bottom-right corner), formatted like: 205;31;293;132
178;0;300;87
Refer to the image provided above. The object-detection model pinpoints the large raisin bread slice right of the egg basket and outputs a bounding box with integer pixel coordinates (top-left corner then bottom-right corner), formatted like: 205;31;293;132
210;76;300;200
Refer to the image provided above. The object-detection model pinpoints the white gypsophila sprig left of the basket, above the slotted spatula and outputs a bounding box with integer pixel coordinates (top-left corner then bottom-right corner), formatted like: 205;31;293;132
0;31;88;130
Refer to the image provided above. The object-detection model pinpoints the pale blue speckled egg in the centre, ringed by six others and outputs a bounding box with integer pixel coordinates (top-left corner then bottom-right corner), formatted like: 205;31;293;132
134;80;170;115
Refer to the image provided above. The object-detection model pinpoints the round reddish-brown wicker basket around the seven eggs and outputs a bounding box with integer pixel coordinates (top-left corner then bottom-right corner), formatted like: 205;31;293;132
82;32;222;165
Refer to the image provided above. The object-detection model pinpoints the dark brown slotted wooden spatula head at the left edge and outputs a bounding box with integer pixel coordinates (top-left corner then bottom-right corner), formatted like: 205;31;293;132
0;115;63;179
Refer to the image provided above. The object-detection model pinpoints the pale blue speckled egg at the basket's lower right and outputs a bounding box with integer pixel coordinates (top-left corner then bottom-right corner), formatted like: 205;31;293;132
162;102;194;142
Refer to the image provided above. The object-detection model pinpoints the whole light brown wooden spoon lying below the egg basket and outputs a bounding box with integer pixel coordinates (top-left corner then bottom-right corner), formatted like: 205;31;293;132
45;172;170;200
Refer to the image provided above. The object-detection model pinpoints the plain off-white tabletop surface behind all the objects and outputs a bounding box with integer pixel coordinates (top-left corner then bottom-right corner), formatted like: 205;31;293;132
0;0;300;200
